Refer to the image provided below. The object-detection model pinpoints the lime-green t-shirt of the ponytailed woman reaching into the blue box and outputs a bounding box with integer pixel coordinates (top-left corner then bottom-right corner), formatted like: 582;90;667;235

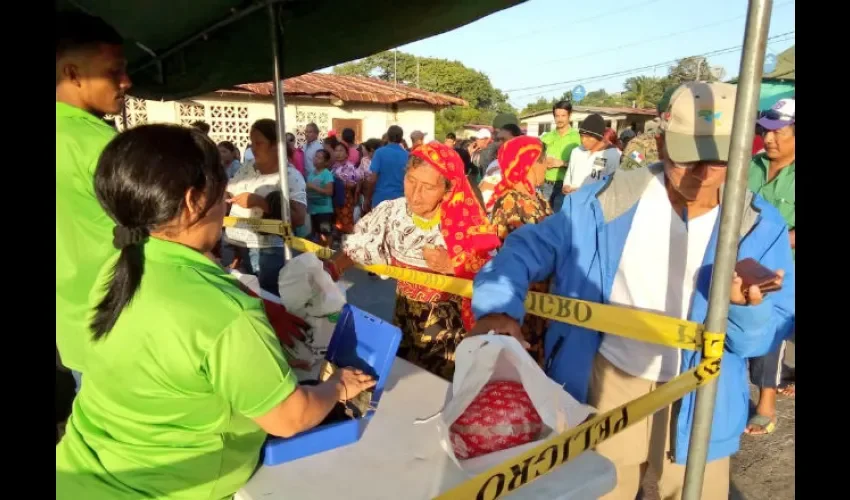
56;238;298;500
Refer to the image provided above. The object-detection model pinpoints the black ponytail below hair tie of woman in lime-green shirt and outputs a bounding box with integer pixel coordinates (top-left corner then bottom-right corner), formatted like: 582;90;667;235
91;226;148;340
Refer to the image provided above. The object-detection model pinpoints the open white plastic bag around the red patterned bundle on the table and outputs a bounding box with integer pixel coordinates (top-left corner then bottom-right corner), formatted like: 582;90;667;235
430;333;595;476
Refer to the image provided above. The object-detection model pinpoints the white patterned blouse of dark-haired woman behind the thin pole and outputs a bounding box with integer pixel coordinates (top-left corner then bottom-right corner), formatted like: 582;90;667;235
224;163;307;248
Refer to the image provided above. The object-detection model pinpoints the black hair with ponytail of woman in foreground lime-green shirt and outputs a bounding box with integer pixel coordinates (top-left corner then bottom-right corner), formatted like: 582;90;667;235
91;124;227;340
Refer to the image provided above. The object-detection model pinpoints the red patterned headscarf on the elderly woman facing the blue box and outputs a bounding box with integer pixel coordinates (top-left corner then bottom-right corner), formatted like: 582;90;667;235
410;141;501;331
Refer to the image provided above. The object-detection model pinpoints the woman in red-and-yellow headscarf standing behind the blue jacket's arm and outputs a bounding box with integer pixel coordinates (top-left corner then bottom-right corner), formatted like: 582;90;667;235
487;136;552;366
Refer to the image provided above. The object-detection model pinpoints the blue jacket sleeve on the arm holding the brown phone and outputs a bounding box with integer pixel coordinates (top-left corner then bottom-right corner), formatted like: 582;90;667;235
726;221;796;358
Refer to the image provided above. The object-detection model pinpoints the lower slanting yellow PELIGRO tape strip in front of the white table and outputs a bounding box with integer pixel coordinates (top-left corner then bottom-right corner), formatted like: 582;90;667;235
434;344;720;500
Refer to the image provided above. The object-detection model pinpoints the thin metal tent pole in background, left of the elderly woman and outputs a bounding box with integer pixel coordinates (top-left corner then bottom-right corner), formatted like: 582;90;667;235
268;3;294;261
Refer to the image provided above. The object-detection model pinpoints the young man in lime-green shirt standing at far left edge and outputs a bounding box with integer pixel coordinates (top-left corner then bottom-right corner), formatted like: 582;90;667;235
56;12;131;378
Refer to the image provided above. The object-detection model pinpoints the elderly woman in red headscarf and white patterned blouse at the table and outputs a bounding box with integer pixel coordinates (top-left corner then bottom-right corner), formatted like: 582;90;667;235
328;141;501;380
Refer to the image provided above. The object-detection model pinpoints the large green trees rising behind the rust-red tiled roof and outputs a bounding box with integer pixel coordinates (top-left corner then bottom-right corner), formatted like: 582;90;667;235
333;51;516;139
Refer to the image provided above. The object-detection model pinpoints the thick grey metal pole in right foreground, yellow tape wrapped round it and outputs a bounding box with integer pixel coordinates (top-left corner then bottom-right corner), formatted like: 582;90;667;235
682;0;773;500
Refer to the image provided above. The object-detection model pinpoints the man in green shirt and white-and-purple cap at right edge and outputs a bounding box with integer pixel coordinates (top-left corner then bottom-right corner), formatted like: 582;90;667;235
746;99;797;435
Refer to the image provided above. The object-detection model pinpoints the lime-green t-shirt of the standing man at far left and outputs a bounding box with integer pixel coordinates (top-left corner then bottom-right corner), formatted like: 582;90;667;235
56;102;116;371
